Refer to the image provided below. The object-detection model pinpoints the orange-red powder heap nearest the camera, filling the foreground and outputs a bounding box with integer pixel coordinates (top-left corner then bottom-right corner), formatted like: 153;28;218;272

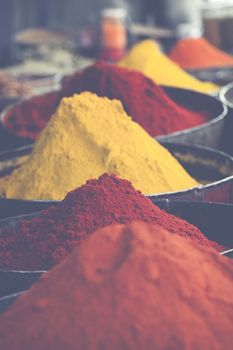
0;223;233;350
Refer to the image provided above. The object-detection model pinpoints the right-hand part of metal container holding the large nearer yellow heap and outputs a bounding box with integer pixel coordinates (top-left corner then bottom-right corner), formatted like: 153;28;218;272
148;142;233;203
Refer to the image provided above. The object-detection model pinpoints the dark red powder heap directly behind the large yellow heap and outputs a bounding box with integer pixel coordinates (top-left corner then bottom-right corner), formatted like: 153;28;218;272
5;62;209;139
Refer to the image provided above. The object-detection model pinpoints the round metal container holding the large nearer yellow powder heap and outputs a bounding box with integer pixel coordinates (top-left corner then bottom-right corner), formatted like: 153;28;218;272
0;142;233;218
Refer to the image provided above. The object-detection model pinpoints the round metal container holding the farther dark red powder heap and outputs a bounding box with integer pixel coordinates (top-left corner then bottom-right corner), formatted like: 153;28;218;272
0;87;228;150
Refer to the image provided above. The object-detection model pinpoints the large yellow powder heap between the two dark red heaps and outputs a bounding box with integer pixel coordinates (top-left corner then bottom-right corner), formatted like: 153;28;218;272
0;92;197;199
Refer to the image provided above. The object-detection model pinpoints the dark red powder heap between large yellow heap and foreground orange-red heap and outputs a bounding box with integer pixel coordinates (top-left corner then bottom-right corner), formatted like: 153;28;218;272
0;174;222;270
